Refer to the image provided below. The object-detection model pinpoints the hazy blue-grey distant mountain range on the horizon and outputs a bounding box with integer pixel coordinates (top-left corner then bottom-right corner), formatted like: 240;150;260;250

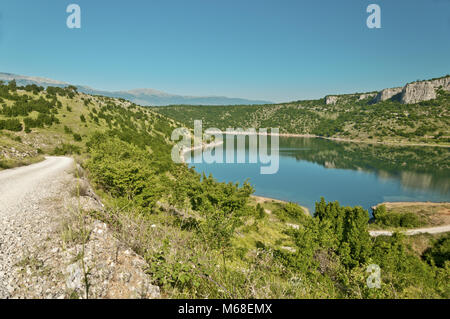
0;73;272;106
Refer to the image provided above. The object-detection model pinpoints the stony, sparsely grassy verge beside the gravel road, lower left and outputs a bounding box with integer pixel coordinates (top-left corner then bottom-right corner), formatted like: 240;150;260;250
0;160;160;299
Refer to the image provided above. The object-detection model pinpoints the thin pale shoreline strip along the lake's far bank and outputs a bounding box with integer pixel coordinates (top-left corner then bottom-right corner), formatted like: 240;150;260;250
209;131;450;148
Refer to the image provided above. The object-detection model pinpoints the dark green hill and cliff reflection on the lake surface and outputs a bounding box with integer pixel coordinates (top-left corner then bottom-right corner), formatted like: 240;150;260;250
280;138;450;194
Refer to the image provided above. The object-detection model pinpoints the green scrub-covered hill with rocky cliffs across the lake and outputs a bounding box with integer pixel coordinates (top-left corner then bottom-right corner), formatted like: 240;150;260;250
154;76;450;145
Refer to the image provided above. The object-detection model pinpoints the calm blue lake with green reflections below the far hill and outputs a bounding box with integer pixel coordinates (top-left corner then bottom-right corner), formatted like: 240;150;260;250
184;137;450;212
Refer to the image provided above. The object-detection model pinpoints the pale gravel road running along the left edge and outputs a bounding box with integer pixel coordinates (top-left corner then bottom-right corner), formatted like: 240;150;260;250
0;157;74;298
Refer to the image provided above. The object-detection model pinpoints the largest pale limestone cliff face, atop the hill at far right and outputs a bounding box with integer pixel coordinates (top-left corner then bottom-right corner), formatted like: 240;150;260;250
401;77;450;104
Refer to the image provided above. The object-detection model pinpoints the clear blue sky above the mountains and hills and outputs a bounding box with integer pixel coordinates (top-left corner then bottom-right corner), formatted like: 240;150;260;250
0;0;450;101
